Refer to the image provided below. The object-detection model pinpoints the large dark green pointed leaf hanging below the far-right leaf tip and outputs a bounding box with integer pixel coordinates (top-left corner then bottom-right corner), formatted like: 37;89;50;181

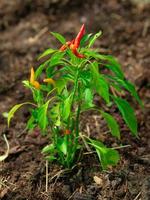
113;97;137;136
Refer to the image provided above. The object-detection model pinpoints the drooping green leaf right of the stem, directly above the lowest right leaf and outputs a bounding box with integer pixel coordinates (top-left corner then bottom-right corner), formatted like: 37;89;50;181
100;111;120;139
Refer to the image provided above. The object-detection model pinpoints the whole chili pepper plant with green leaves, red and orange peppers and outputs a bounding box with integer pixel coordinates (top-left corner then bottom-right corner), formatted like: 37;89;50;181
8;24;142;169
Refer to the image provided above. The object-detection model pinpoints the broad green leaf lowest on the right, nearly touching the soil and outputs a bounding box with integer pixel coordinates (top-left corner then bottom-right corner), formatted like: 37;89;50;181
89;139;120;169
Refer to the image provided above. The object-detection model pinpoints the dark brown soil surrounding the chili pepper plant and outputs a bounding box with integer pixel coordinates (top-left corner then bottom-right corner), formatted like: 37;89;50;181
0;0;150;200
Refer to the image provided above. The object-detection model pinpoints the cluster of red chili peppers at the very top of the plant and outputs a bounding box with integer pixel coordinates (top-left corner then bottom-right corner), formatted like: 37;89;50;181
59;24;85;58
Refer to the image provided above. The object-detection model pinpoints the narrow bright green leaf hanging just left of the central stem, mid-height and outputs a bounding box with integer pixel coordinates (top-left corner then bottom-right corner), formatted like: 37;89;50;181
62;94;72;121
